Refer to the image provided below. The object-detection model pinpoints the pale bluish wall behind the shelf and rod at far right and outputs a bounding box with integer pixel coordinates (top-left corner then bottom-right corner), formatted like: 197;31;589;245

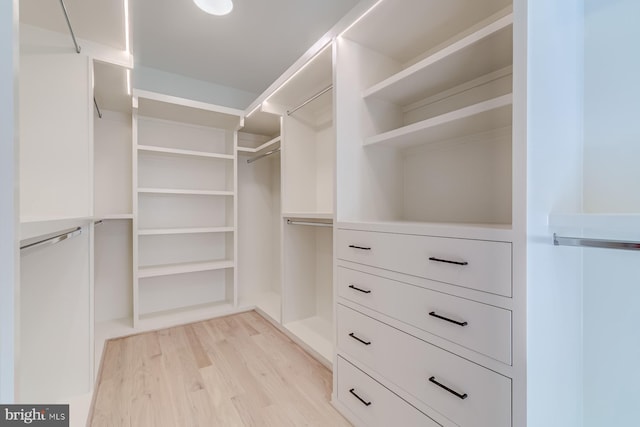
583;0;640;427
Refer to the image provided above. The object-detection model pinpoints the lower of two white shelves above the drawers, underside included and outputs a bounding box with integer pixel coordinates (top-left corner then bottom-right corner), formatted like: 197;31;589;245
364;94;512;147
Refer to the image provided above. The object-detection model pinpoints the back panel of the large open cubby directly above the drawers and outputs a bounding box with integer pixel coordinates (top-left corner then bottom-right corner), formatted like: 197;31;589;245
403;128;511;224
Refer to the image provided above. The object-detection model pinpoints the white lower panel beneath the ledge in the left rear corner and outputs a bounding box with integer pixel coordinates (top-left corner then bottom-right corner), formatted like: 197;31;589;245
94;220;133;323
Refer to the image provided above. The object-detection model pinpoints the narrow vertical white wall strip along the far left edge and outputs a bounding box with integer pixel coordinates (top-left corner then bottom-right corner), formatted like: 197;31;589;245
0;0;20;403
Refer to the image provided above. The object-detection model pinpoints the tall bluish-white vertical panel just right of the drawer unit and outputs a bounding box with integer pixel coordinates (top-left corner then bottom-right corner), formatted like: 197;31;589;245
522;0;583;427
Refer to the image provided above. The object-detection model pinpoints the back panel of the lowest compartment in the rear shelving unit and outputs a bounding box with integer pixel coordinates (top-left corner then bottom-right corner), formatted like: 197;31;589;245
139;270;230;315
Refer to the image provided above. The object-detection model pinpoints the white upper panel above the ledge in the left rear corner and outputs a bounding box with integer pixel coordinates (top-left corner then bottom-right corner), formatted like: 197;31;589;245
94;111;132;216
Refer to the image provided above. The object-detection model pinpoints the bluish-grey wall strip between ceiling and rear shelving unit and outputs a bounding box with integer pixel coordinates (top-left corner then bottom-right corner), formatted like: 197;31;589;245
133;65;258;109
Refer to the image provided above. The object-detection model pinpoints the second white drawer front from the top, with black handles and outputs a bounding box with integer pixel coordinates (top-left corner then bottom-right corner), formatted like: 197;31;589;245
338;267;511;365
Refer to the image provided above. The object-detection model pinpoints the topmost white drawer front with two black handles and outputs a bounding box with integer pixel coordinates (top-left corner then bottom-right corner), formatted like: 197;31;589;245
337;229;511;297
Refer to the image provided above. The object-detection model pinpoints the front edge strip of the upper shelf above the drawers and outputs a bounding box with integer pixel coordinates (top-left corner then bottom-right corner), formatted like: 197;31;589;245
362;13;513;99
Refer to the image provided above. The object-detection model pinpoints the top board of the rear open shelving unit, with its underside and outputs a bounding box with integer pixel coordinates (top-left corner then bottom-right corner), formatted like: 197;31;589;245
133;89;244;130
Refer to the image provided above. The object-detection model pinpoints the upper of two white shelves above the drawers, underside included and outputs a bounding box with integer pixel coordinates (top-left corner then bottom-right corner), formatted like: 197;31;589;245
363;14;513;105
